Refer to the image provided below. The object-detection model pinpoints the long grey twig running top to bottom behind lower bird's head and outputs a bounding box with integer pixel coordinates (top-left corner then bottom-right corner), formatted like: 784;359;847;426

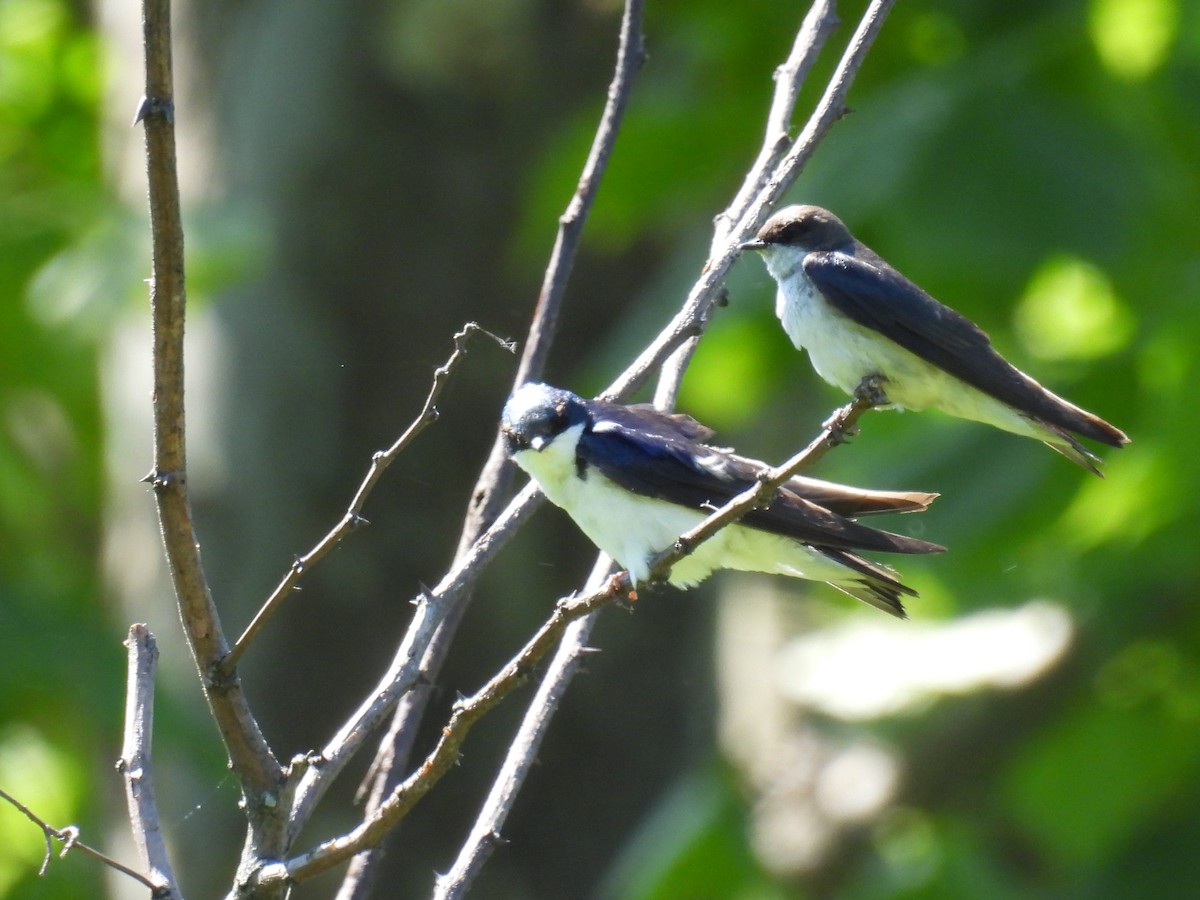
338;0;646;900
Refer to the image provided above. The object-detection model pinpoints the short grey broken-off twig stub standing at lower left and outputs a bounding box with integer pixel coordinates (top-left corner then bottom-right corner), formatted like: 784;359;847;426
116;625;180;900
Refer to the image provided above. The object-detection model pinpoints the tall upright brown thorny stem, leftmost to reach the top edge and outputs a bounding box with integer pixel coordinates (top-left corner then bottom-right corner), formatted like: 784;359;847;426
137;0;282;811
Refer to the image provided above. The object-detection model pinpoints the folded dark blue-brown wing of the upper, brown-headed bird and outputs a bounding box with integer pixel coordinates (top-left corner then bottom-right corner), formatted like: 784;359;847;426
804;248;1128;446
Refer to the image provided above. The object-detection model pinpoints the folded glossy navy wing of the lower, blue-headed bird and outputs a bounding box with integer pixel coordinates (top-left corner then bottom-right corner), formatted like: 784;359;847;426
577;404;942;553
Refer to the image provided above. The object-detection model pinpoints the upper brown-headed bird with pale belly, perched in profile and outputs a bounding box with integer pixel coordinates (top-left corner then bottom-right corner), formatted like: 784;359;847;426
742;206;1129;475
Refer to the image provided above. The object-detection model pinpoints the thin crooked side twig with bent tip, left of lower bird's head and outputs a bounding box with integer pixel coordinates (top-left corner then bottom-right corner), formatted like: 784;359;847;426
217;322;514;678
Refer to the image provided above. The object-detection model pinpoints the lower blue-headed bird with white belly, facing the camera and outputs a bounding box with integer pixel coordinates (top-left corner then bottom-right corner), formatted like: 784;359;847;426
500;383;944;618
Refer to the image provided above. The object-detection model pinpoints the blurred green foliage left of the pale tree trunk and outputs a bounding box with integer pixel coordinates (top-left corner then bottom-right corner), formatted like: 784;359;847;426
0;0;111;898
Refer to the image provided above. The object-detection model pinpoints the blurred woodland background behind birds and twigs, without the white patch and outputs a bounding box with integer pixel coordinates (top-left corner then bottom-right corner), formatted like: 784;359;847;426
0;0;1200;898
